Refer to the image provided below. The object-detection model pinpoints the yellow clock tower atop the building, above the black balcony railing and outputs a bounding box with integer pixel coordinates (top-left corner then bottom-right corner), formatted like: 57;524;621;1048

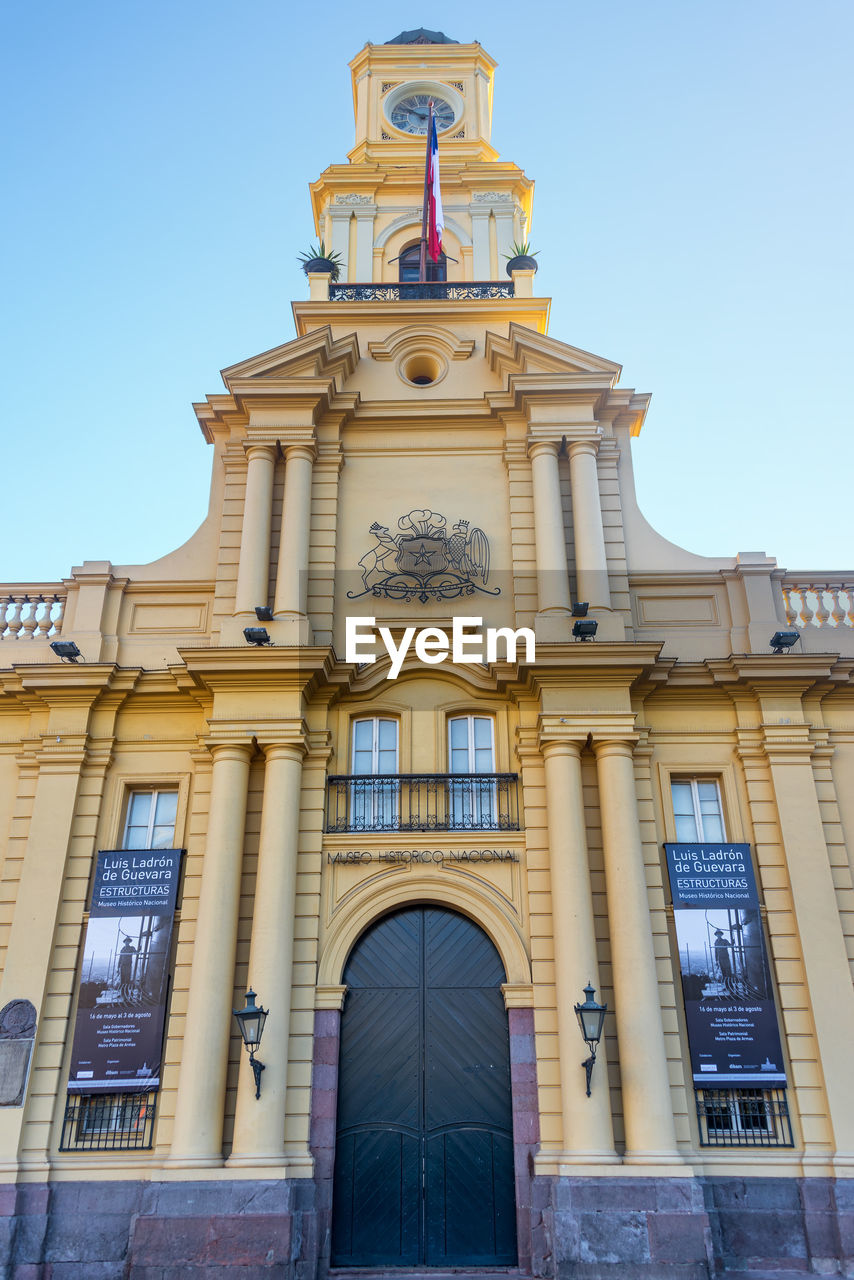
311;28;534;284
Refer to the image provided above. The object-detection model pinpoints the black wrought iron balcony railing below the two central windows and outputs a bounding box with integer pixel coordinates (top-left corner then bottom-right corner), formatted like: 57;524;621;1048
326;773;519;832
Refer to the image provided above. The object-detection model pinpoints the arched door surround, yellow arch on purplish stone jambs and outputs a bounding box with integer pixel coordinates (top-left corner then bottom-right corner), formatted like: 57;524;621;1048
310;872;539;1277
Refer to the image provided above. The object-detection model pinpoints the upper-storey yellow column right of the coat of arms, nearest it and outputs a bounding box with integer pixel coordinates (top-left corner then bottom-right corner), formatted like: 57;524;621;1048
528;440;570;641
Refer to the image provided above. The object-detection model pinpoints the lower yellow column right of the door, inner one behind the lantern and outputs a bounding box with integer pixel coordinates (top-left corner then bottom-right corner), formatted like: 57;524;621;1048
543;741;616;1164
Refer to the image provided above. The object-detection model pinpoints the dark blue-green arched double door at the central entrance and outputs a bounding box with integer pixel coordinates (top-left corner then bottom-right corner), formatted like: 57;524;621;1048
332;906;516;1267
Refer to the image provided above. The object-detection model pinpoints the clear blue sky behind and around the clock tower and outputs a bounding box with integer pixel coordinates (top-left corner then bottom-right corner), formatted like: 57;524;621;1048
0;0;854;582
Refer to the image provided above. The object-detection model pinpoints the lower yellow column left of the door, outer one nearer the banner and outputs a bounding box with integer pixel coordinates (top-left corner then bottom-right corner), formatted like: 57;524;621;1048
169;742;252;1167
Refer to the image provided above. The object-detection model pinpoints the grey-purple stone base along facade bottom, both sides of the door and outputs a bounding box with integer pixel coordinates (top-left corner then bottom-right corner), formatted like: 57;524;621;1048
0;1178;854;1280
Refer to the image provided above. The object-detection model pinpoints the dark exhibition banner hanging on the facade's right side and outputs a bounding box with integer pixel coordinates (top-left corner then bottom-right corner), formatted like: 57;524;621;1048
665;844;786;1088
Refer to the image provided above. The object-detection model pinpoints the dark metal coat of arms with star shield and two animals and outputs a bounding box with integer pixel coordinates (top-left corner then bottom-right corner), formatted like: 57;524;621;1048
347;509;501;604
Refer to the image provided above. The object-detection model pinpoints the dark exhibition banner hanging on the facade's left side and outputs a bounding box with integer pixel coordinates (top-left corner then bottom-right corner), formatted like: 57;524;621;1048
68;849;183;1093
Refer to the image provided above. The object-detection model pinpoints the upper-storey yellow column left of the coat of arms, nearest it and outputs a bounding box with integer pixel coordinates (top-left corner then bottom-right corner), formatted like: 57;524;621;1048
274;442;315;644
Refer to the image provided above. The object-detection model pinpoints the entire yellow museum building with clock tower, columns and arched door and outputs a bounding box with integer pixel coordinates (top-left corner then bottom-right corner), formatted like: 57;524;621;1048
0;31;854;1280
